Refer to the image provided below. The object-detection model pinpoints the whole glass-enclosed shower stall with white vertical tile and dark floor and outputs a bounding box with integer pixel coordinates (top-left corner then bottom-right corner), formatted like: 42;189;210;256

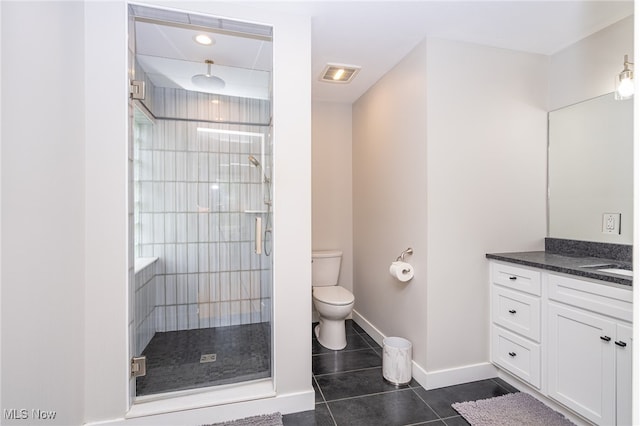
129;5;274;400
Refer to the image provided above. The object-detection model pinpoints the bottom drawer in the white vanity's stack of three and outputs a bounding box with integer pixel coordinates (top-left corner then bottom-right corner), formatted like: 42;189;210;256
491;325;540;389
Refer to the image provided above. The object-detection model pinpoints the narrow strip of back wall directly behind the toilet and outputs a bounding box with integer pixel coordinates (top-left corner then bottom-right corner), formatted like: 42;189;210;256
311;102;353;290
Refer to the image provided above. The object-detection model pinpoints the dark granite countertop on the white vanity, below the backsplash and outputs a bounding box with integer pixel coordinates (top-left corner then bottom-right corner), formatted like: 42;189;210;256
486;251;633;286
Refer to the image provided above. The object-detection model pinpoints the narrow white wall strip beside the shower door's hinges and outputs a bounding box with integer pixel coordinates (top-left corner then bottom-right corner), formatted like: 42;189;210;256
84;2;128;421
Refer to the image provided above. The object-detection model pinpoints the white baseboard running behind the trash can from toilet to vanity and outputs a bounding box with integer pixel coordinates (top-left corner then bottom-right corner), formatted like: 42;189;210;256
353;309;498;390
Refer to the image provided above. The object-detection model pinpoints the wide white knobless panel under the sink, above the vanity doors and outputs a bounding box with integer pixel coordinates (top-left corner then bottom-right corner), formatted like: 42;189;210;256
548;274;633;322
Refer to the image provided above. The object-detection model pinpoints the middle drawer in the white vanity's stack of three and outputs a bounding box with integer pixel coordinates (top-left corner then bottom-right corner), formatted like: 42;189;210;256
491;285;540;342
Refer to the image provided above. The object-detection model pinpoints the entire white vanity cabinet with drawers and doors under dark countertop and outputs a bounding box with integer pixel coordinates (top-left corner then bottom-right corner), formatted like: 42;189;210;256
490;261;632;426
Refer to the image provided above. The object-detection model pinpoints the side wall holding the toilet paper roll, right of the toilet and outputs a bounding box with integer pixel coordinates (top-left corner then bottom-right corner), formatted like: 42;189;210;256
353;43;428;365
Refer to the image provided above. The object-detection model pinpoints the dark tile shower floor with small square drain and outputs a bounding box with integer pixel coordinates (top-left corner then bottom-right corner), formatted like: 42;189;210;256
136;323;271;396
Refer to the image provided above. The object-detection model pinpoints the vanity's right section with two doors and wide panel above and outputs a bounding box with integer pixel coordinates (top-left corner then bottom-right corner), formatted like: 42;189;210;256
546;274;632;425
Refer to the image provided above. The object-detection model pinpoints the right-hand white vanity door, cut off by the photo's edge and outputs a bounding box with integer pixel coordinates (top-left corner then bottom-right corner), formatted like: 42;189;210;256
615;323;633;425
